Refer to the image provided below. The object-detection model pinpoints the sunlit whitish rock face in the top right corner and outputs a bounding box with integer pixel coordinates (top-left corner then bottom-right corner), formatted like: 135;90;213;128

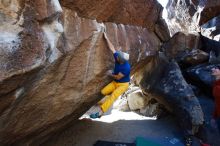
167;0;220;35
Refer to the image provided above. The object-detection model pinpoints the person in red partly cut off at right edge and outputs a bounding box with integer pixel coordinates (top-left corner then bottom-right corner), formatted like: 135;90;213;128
211;68;220;132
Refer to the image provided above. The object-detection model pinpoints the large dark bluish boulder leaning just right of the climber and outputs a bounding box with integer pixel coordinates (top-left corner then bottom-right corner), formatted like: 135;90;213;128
136;54;204;135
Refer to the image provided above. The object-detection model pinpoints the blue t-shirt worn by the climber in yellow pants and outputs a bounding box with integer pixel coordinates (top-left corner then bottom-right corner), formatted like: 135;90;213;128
113;52;131;83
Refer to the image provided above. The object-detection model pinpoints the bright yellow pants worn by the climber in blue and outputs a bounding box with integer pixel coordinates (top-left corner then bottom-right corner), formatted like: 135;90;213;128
100;81;129;112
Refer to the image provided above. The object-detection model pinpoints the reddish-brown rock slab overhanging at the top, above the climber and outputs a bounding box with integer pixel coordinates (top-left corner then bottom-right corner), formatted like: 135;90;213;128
61;0;162;30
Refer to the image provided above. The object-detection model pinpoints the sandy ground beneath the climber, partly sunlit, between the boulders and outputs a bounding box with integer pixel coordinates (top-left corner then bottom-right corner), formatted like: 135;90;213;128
43;106;183;146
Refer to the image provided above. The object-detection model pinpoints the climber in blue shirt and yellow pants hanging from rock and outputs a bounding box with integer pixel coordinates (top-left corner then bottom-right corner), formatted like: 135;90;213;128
90;33;130;118
